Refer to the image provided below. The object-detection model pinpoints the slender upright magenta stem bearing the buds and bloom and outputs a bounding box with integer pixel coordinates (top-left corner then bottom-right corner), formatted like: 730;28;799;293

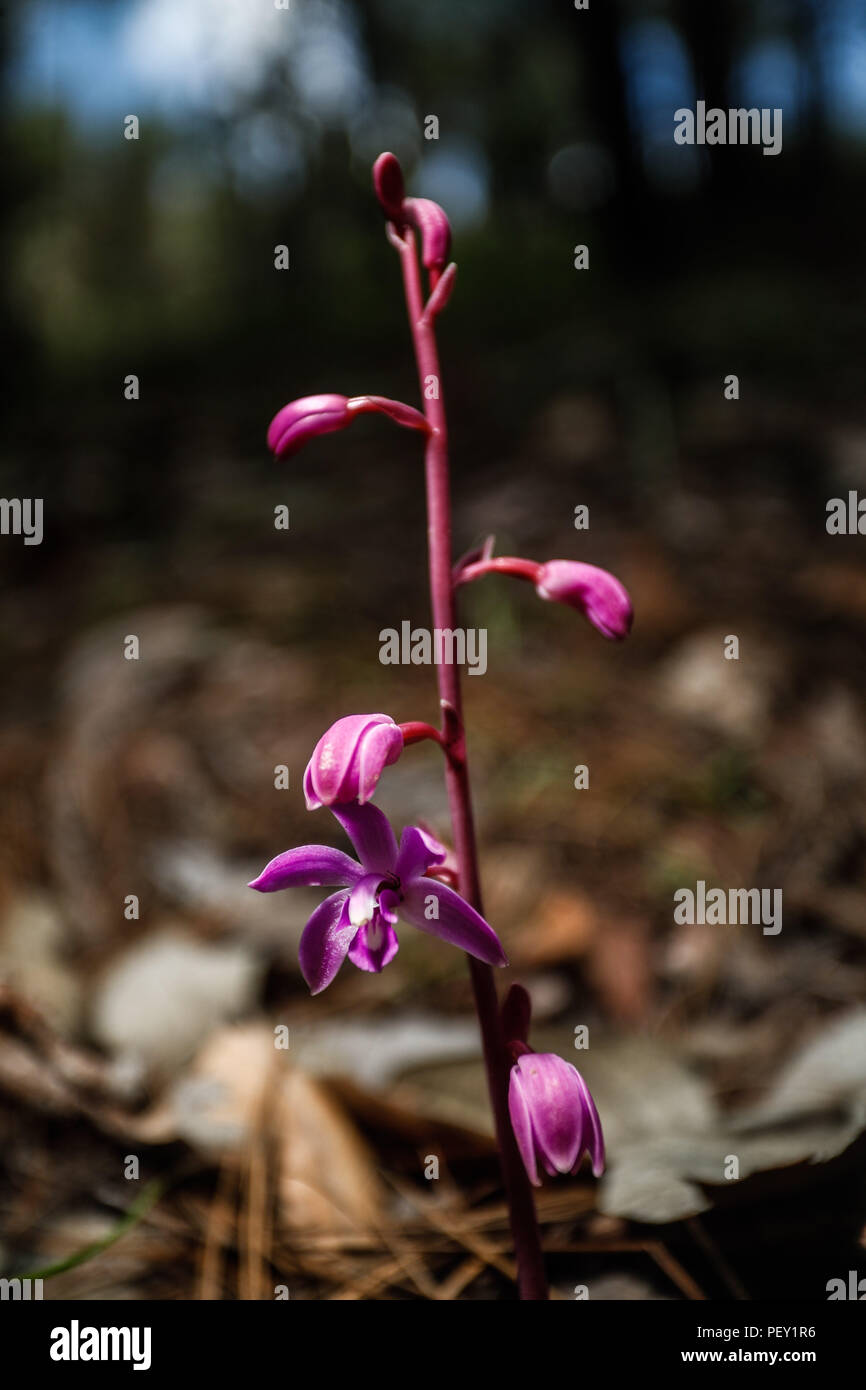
391;228;548;1300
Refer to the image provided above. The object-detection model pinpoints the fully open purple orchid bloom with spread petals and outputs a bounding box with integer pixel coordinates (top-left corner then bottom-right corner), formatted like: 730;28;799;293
250;802;507;994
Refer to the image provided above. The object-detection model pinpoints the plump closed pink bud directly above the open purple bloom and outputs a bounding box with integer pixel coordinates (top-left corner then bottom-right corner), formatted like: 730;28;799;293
303;714;403;810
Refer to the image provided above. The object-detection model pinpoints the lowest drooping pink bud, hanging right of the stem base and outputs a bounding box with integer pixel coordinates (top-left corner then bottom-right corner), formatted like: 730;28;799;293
509;1052;605;1187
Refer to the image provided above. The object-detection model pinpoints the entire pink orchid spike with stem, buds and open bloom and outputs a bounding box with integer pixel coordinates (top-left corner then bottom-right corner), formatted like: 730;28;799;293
250;153;631;1298
